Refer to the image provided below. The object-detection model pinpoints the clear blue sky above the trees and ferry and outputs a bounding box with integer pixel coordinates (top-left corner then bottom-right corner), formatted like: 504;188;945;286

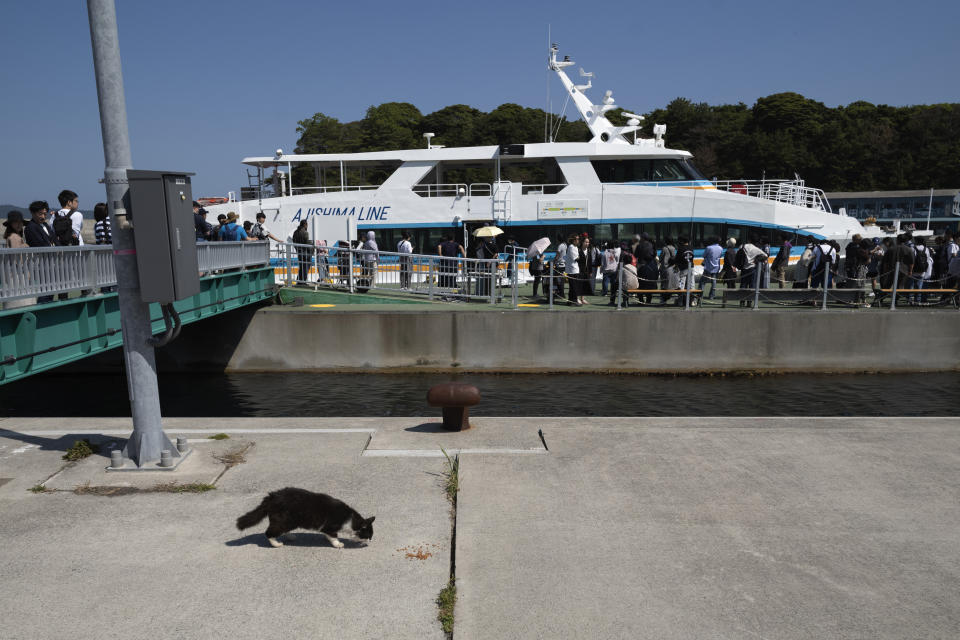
0;0;960;209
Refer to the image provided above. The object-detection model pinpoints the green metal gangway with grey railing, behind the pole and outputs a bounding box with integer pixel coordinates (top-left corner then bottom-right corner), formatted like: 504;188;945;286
0;242;276;384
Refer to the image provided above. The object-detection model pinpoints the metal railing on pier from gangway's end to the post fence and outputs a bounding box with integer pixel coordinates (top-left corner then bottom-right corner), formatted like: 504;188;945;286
273;242;507;304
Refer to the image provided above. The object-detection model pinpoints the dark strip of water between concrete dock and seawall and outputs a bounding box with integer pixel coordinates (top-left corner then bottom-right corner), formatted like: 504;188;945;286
0;373;960;417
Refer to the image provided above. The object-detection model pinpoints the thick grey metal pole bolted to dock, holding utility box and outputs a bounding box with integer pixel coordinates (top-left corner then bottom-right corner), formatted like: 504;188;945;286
87;0;182;469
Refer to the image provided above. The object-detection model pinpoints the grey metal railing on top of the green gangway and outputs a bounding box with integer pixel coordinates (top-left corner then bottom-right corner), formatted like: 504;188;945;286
0;242;270;302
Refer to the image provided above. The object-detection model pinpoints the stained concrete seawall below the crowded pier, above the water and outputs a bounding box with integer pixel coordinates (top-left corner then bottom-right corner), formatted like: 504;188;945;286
221;308;960;373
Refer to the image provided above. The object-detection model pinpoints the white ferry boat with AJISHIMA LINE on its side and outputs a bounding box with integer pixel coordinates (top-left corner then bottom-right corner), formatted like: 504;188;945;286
207;45;867;255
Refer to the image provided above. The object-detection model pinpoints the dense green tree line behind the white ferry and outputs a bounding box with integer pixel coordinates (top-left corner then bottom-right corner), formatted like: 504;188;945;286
294;92;960;191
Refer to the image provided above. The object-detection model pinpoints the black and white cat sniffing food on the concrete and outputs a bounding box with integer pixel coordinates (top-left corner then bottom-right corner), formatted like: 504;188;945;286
237;487;376;549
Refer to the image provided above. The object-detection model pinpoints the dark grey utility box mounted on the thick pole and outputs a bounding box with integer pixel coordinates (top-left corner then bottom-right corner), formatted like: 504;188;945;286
127;170;200;304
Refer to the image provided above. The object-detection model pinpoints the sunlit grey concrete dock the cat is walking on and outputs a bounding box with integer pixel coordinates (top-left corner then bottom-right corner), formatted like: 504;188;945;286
0;418;960;640
